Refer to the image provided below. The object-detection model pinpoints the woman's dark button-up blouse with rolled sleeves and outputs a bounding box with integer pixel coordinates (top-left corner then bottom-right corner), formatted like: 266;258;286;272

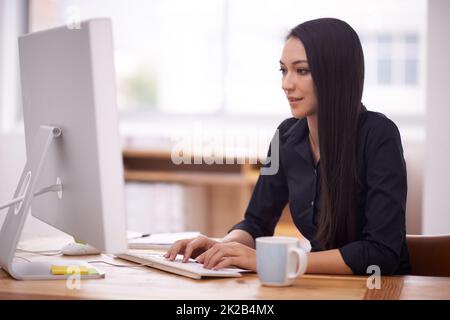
231;108;410;274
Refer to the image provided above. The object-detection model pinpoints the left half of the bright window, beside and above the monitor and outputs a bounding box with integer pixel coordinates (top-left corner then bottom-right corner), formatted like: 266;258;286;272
31;0;223;113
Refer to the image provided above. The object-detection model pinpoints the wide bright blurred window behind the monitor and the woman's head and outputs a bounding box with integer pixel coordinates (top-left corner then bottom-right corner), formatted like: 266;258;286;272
26;0;426;127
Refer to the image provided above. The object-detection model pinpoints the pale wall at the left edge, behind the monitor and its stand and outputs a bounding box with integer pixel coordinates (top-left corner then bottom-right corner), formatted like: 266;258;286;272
0;0;67;239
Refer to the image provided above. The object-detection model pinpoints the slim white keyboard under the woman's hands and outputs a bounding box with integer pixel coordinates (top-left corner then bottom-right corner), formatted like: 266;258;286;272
117;253;248;279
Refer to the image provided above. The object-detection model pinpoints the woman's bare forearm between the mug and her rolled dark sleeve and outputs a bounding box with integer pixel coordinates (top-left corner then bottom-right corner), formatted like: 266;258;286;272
306;249;353;274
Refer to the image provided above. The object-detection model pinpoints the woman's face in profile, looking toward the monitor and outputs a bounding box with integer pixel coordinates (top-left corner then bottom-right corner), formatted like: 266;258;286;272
280;37;317;118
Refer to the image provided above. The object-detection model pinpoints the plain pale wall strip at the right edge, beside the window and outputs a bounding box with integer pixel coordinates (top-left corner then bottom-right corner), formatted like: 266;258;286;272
422;0;450;234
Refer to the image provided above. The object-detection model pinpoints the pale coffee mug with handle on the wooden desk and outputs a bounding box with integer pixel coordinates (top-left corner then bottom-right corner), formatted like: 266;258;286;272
256;237;308;286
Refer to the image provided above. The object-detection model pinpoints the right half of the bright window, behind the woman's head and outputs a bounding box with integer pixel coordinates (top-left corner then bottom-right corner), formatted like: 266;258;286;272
225;0;426;121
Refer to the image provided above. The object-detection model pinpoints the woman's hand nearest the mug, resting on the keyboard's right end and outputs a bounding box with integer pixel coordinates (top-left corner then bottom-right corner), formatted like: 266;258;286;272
195;242;256;271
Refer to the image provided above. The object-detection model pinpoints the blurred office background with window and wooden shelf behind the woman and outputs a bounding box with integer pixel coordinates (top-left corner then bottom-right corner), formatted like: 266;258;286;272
0;0;450;240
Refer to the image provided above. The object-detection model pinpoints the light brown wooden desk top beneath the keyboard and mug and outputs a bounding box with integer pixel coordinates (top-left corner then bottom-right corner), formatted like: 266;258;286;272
0;239;450;300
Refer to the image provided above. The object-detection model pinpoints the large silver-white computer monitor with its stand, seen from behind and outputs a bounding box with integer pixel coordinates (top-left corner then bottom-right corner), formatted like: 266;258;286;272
0;18;127;279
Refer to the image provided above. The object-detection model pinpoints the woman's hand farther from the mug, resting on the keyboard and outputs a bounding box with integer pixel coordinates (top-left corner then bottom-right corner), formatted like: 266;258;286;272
164;235;219;262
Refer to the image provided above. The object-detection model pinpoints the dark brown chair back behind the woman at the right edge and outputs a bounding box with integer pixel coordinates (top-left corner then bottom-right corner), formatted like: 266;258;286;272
406;234;450;277
